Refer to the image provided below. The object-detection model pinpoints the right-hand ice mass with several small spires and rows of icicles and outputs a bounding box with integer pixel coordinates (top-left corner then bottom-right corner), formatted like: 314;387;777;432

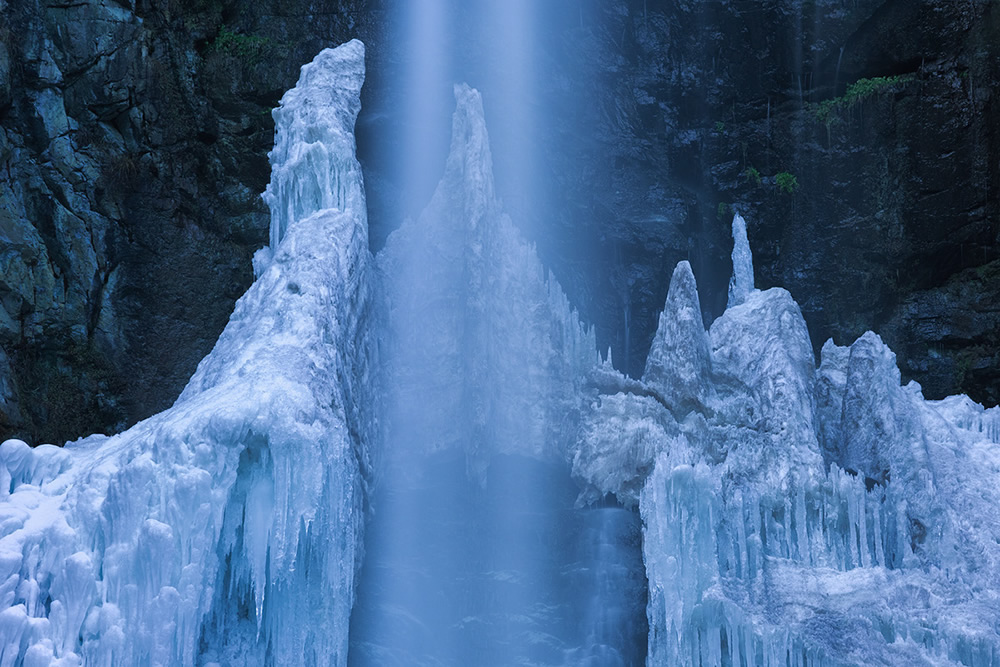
574;216;1000;667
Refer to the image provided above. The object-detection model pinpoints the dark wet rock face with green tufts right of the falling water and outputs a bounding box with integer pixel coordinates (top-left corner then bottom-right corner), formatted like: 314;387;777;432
536;0;1000;403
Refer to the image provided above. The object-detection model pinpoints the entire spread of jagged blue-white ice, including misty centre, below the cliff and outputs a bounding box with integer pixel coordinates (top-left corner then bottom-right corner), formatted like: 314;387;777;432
0;41;1000;667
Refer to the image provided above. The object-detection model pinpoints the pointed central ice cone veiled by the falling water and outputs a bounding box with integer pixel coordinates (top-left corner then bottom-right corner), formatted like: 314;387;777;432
378;85;598;480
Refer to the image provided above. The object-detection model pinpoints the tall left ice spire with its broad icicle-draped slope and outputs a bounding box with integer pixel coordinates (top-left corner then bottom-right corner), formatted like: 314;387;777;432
0;41;375;665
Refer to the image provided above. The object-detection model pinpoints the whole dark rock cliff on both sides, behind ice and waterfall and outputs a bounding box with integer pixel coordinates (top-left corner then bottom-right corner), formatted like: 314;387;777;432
0;0;1000;442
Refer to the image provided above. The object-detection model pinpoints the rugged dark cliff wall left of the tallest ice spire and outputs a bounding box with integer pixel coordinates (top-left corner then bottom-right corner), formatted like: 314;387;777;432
0;0;374;443
